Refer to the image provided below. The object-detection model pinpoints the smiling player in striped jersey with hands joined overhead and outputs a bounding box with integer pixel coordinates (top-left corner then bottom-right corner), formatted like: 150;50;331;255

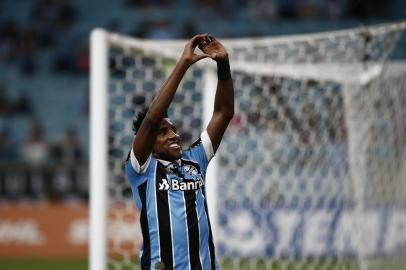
125;34;234;270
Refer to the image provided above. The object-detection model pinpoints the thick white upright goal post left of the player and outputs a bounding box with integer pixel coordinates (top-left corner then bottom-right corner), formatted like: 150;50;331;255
89;30;108;270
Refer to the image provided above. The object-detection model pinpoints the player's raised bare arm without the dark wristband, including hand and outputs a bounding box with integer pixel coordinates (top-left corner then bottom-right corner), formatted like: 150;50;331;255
133;34;209;166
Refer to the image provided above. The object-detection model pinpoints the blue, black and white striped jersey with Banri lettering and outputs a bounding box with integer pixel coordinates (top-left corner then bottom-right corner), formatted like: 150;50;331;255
125;131;219;270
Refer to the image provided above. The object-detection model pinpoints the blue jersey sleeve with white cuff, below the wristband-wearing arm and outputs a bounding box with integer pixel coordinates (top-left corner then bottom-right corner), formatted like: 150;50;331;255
185;131;214;174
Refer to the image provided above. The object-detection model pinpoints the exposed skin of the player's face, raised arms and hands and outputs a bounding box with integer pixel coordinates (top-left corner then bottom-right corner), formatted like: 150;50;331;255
133;34;234;165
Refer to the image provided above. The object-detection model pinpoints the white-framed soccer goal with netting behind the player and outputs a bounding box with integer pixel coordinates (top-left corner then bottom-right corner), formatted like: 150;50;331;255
90;23;406;270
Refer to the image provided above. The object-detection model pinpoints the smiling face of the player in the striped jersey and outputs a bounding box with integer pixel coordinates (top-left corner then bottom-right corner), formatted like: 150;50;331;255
154;118;182;161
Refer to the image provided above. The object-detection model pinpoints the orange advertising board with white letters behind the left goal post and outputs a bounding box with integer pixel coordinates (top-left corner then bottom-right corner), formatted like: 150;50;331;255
0;203;142;259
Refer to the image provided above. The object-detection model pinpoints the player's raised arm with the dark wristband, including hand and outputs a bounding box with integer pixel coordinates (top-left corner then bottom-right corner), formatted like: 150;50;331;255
199;36;234;152
